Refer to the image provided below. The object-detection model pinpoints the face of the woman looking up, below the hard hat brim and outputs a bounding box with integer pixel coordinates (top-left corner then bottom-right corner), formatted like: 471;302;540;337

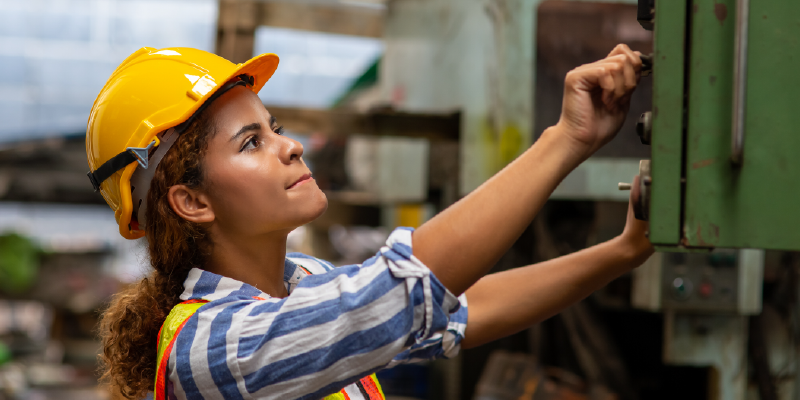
198;86;328;235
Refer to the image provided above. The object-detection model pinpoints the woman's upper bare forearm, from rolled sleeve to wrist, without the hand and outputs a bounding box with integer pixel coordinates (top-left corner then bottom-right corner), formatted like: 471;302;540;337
413;128;585;295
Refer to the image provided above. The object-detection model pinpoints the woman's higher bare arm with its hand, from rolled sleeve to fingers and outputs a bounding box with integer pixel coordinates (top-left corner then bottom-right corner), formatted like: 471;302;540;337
413;45;641;295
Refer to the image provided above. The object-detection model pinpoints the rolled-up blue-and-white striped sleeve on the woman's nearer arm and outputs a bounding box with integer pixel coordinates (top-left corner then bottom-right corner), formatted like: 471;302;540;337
227;228;467;399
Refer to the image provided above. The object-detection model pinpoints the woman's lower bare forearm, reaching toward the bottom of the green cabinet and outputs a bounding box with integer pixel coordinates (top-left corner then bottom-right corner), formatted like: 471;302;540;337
462;236;652;348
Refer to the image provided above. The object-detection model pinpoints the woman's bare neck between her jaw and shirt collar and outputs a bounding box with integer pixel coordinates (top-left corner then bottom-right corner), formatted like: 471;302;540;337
206;233;289;297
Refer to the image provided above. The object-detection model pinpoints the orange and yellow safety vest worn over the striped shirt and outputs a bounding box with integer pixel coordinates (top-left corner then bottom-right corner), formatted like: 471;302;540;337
153;300;386;400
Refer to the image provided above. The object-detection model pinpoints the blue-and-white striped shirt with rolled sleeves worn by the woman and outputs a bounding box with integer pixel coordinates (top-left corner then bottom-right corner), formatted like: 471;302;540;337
167;228;467;400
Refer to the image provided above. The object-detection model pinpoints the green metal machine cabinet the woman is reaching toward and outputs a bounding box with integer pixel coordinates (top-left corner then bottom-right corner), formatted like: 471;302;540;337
637;0;800;251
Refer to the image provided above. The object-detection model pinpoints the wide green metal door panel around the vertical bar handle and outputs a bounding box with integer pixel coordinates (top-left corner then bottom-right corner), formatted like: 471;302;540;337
680;0;800;250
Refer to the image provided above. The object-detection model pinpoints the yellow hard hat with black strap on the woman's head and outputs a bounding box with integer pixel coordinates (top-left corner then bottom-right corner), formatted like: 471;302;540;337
86;47;278;239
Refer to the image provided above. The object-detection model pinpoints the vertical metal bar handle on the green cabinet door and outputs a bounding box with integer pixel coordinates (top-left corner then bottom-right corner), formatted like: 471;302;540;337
731;0;750;165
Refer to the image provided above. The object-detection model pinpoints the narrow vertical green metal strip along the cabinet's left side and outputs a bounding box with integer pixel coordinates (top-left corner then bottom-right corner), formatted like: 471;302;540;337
645;0;687;244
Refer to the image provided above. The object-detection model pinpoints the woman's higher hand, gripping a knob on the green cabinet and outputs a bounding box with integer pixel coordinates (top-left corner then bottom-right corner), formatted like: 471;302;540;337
556;44;642;158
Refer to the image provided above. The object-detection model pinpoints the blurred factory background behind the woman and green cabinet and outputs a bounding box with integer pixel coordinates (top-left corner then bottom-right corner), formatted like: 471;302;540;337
0;0;800;400
